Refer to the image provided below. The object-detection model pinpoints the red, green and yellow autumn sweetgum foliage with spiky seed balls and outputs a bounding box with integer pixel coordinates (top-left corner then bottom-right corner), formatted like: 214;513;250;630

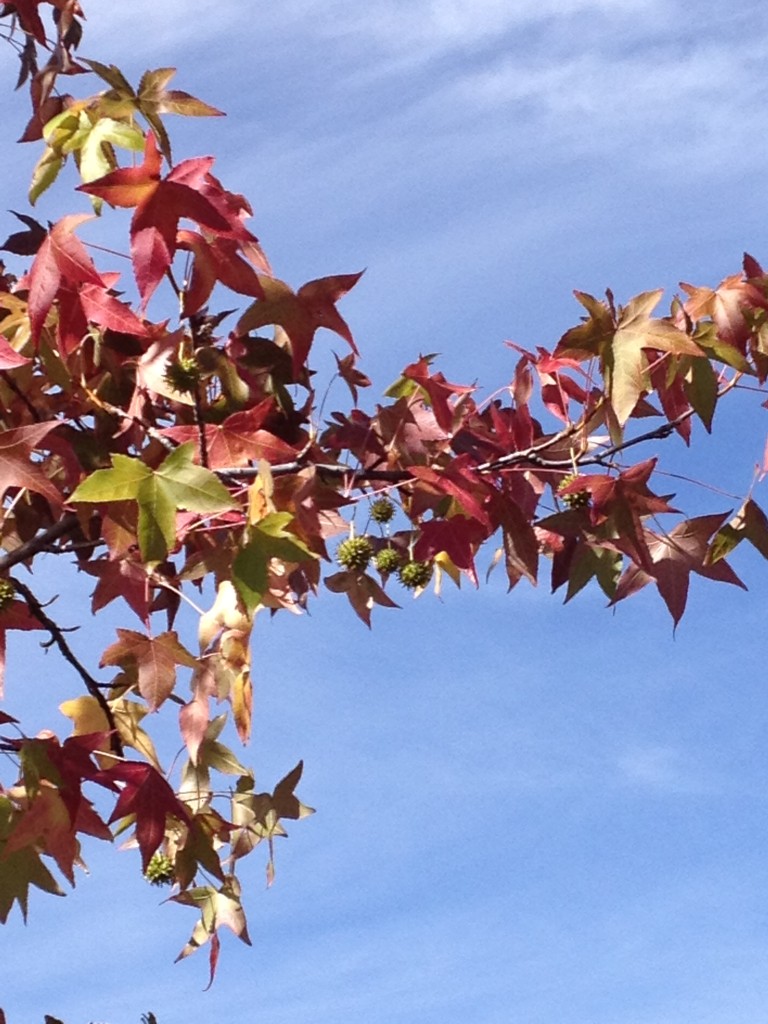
0;0;768;1003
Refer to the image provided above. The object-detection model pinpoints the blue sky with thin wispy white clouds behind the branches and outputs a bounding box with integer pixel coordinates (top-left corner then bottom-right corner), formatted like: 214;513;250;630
0;0;768;1024
